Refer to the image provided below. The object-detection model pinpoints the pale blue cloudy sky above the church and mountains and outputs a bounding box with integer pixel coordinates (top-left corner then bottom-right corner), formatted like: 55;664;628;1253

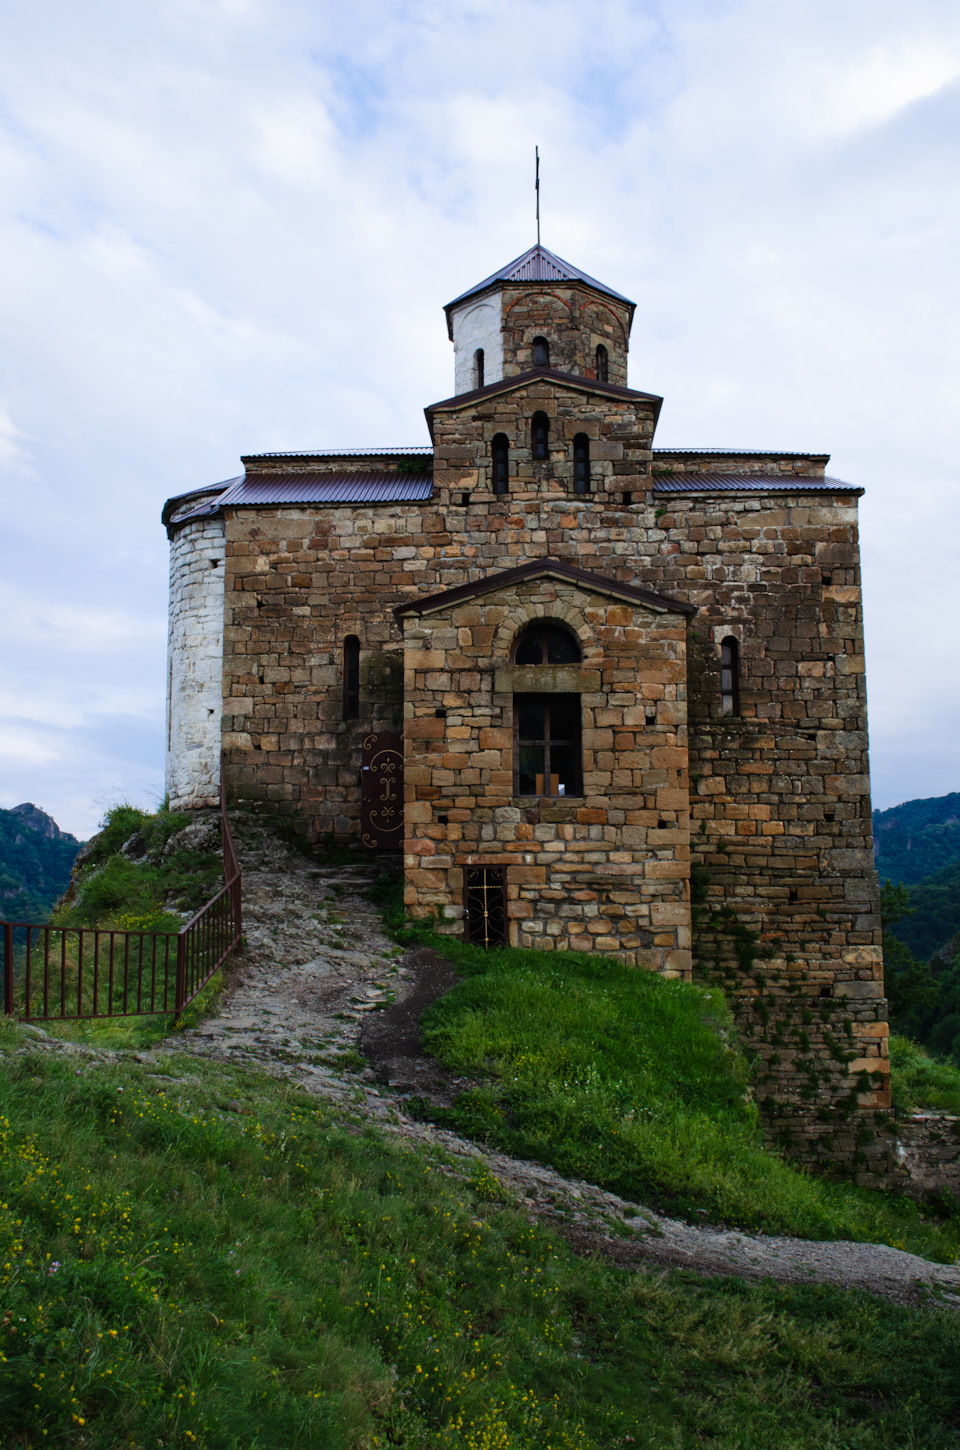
0;0;960;838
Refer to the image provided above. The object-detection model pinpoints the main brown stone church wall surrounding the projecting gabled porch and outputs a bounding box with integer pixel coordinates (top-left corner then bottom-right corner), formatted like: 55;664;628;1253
216;383;889;1172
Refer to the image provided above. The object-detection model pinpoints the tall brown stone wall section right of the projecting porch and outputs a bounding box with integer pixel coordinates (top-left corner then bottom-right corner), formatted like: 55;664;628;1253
643;494;892;1179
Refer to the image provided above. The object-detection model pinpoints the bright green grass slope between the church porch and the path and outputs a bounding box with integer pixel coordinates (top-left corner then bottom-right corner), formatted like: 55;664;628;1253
400;938;960;1263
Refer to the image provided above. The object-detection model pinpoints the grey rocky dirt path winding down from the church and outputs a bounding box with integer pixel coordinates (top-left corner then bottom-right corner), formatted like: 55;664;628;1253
18;818;960;1308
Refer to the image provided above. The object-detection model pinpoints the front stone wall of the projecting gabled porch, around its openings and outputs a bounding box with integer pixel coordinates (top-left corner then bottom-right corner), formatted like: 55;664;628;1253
405;577;690;976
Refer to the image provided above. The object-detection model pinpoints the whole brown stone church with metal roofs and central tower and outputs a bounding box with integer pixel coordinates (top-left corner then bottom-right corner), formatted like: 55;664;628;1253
162;237;889;1163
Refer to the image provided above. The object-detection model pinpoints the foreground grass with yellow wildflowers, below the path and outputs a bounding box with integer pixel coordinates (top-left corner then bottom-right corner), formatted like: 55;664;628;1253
0;1025;960;1450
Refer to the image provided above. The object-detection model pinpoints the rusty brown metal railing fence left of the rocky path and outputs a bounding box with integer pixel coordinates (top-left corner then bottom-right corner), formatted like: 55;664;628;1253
0;761;242;1021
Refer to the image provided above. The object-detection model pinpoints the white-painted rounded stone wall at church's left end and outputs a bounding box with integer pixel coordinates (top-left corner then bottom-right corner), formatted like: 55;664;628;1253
167;518;226;811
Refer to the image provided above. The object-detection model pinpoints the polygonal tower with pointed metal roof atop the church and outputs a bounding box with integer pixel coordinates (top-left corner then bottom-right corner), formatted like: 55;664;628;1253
444;244;635;393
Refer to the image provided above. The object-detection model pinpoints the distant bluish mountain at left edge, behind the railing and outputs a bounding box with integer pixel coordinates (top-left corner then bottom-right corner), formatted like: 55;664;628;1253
0;805;81;922
